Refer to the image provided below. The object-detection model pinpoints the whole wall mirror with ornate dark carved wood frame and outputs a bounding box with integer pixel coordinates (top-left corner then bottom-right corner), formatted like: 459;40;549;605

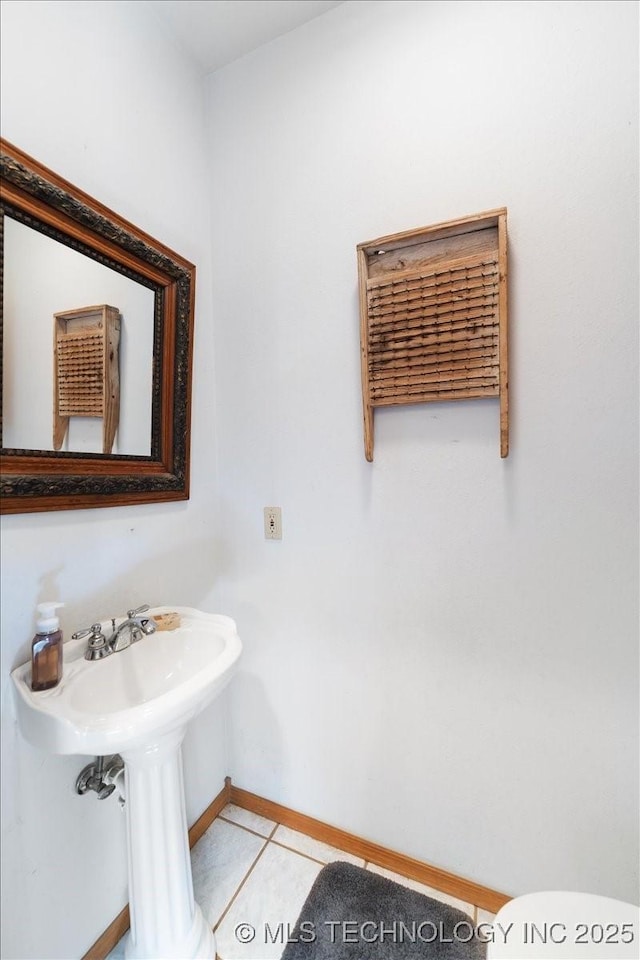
0;140;195;513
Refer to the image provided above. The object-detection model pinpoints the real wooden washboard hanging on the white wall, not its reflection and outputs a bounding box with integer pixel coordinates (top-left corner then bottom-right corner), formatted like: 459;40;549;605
357;208;509;460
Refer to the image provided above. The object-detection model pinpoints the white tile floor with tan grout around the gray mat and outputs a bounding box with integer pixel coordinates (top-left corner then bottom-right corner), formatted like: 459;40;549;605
107;804;493;960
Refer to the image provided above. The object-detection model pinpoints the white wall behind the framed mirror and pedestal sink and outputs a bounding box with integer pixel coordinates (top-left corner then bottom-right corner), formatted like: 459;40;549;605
1;0;227;960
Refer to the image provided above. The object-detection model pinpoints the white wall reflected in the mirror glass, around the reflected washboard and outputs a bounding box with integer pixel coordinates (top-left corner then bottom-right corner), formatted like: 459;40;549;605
2;216;154;457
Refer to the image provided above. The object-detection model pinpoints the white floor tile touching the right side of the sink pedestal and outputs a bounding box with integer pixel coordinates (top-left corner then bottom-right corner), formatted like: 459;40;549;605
191;820;266;927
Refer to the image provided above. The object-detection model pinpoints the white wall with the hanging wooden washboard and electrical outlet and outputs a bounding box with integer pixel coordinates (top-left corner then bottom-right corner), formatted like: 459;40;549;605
209;0;638;900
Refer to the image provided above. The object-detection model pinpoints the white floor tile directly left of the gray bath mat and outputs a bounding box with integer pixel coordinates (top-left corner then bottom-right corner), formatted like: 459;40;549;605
215;843;322;960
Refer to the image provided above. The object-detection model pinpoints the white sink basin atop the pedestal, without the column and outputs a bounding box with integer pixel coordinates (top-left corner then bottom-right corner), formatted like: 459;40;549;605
12;607;242;756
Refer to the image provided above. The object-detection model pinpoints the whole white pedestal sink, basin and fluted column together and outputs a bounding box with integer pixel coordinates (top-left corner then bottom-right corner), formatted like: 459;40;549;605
11;607;242;960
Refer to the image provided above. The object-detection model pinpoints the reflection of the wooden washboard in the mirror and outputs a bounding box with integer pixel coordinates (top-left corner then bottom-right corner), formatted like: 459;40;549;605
53;304;120;454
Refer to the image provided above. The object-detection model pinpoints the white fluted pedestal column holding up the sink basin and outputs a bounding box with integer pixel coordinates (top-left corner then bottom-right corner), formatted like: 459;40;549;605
117;727;216;960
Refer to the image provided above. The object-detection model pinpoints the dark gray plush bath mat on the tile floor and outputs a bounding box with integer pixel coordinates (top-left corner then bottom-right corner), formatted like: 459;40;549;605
282;862;486;960
